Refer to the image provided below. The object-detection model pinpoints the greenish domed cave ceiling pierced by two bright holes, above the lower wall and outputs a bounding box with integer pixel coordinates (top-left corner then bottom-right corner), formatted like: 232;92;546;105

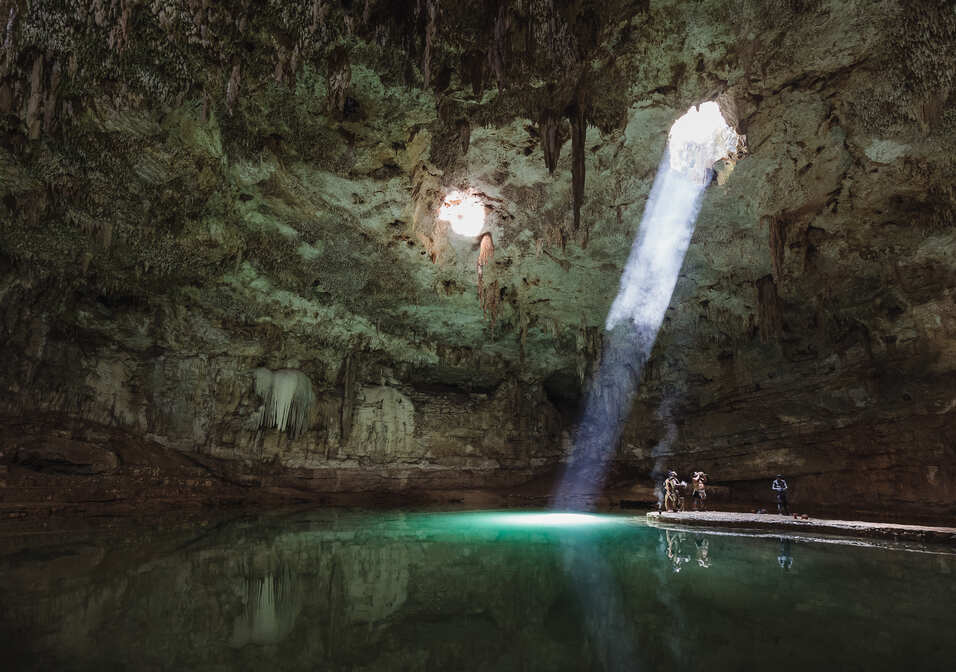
0;0;956;405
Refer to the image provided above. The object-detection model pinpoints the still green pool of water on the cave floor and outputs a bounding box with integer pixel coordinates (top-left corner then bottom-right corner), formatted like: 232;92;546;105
0;511;956;672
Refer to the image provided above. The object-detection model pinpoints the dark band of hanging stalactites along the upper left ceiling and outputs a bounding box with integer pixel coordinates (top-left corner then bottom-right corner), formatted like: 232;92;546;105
0;0;620;171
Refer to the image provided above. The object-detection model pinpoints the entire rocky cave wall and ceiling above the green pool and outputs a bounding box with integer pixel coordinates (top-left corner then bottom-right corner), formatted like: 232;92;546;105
0;0;956;516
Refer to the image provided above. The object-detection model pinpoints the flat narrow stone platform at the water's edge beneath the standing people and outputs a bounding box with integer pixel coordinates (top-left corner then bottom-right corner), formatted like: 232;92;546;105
647;511;956;545
